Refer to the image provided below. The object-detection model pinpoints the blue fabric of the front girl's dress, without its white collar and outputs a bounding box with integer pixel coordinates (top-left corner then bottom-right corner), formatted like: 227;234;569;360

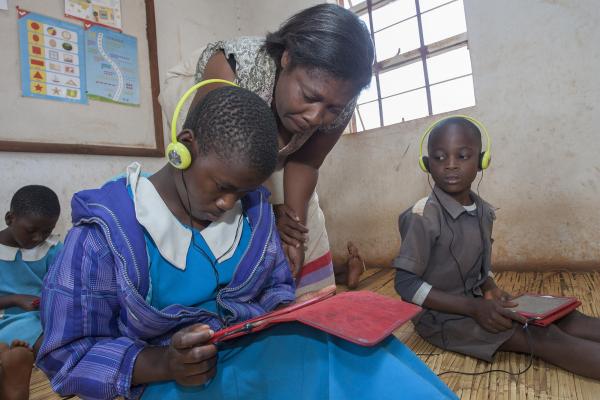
137;218;457;400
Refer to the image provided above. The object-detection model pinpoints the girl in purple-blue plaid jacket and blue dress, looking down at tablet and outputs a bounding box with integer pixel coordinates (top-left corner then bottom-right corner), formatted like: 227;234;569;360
38;87;456;400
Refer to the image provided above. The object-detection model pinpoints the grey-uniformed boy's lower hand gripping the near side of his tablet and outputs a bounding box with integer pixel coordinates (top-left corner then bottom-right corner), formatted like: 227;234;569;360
471;298;525;333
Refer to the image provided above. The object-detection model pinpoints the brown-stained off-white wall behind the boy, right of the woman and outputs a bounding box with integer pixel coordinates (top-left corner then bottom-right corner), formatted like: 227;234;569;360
319;0;600;269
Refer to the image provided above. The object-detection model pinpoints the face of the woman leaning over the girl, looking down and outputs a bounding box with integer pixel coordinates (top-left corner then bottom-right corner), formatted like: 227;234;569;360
274;51;356;134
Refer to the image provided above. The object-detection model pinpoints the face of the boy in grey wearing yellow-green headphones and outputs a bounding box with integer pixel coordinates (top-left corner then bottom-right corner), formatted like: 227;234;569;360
428;124;481;202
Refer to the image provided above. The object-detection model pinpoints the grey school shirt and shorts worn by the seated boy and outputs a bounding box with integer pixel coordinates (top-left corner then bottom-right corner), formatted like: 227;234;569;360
393;187;514;361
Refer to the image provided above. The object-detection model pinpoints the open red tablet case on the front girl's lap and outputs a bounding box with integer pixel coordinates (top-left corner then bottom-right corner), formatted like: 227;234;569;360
211;291;421;346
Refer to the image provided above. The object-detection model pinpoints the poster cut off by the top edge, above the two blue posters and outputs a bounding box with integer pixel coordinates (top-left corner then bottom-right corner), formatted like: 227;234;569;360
65;0;122;31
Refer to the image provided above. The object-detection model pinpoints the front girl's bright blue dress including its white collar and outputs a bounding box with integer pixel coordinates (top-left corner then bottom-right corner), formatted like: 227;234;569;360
112;163;457;400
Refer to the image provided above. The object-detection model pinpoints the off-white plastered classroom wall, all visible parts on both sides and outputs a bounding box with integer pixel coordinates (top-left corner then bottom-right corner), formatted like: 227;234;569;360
0;0;600;268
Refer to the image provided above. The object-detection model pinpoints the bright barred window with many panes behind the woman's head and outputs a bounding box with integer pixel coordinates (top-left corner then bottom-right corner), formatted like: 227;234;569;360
338;0;475;132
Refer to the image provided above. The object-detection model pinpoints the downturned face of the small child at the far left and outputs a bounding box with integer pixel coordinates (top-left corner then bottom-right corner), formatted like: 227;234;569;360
5;211;58;249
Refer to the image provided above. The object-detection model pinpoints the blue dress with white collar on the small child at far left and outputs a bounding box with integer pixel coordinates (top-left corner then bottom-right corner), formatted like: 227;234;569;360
0;236;62;346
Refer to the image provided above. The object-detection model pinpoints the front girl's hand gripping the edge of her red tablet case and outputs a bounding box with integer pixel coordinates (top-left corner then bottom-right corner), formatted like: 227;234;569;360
165;324;217;386
